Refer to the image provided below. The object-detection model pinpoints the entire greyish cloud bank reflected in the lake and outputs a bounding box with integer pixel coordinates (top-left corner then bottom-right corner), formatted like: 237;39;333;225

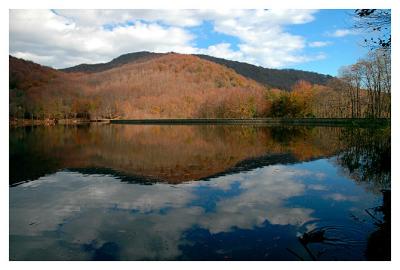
10;166;314;260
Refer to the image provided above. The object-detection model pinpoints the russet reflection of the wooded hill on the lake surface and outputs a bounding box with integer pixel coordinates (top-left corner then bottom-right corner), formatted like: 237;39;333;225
10;125;339;184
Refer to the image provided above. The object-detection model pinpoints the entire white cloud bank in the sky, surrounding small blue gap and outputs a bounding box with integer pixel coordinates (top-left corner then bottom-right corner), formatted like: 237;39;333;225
10;10;320;68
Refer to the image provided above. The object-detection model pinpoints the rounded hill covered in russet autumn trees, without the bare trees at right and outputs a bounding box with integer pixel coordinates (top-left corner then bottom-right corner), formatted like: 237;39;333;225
9;53;268;119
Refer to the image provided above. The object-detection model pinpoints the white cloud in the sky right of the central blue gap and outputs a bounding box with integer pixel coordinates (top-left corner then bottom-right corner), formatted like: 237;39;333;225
206;10;315;67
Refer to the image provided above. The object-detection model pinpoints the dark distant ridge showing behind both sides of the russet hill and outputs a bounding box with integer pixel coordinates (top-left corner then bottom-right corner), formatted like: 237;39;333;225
61;51;332;91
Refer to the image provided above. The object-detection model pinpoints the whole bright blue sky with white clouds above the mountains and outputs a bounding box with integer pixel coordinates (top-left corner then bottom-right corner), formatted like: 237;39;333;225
9;9;368;76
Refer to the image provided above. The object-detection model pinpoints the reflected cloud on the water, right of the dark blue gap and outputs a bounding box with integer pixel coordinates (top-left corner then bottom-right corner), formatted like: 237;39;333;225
199;165;314;233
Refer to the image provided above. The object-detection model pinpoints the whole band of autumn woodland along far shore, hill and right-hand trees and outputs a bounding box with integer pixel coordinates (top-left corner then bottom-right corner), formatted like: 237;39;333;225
9;51;391;120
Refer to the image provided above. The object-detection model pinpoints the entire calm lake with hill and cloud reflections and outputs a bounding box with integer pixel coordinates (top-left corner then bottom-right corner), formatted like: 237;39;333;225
9;124;391;260
